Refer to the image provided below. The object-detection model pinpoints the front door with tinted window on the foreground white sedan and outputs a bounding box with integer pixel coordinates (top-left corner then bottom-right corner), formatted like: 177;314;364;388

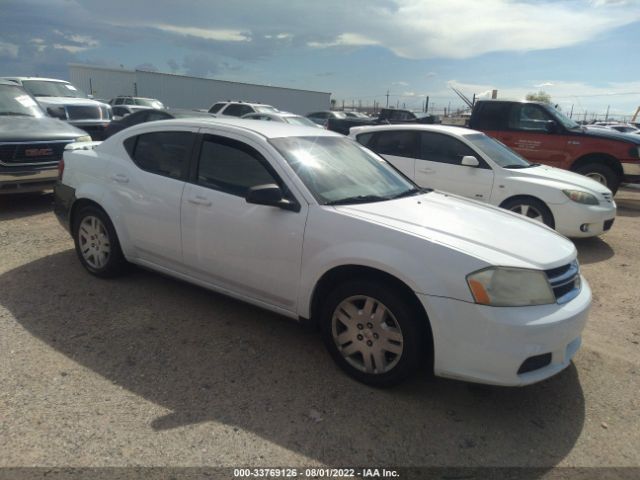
182;131;307;311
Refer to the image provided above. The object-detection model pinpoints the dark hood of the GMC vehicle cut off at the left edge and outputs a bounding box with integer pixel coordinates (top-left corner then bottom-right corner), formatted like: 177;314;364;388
0;116;87;142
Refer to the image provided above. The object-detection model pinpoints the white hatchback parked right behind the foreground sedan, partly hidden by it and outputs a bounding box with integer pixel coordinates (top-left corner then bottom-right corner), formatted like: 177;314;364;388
349;125;616;237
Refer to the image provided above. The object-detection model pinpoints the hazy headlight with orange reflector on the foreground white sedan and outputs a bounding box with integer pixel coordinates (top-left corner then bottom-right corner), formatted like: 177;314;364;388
467;267;556;307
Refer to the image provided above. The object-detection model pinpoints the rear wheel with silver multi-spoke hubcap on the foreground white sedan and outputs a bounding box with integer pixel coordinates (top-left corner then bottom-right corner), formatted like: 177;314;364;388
73;206;127;278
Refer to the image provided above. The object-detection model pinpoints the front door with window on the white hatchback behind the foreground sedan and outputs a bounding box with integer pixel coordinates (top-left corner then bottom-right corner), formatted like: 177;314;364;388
415;132;493;202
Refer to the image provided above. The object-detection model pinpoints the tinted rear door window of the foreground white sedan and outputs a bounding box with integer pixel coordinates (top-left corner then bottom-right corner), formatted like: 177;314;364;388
125;132;194;178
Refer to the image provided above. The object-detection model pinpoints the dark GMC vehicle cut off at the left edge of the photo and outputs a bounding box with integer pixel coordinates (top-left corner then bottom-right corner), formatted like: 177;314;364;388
0;79;91;194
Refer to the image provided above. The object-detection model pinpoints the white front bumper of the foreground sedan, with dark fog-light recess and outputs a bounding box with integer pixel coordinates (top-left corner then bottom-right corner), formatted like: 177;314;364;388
418;278;591;386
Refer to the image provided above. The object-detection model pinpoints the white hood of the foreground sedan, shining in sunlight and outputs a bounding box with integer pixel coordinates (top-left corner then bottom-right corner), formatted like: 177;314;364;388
334;191;576;270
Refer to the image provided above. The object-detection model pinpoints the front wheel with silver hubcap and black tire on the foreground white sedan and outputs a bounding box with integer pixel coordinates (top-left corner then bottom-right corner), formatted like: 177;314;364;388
321;280;425;387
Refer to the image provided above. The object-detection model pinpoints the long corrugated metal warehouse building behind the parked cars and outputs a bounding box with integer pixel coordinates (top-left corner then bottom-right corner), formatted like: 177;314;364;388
69;63;331;115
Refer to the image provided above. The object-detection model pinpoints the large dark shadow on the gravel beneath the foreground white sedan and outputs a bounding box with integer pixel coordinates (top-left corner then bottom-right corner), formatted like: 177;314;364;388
0;250;585;468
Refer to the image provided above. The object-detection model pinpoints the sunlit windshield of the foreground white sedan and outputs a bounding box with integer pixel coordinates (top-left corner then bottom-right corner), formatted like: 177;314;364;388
270;136;422;205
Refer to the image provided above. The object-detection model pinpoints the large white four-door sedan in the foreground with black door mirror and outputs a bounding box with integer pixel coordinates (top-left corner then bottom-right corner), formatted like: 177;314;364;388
55;118;591;385
